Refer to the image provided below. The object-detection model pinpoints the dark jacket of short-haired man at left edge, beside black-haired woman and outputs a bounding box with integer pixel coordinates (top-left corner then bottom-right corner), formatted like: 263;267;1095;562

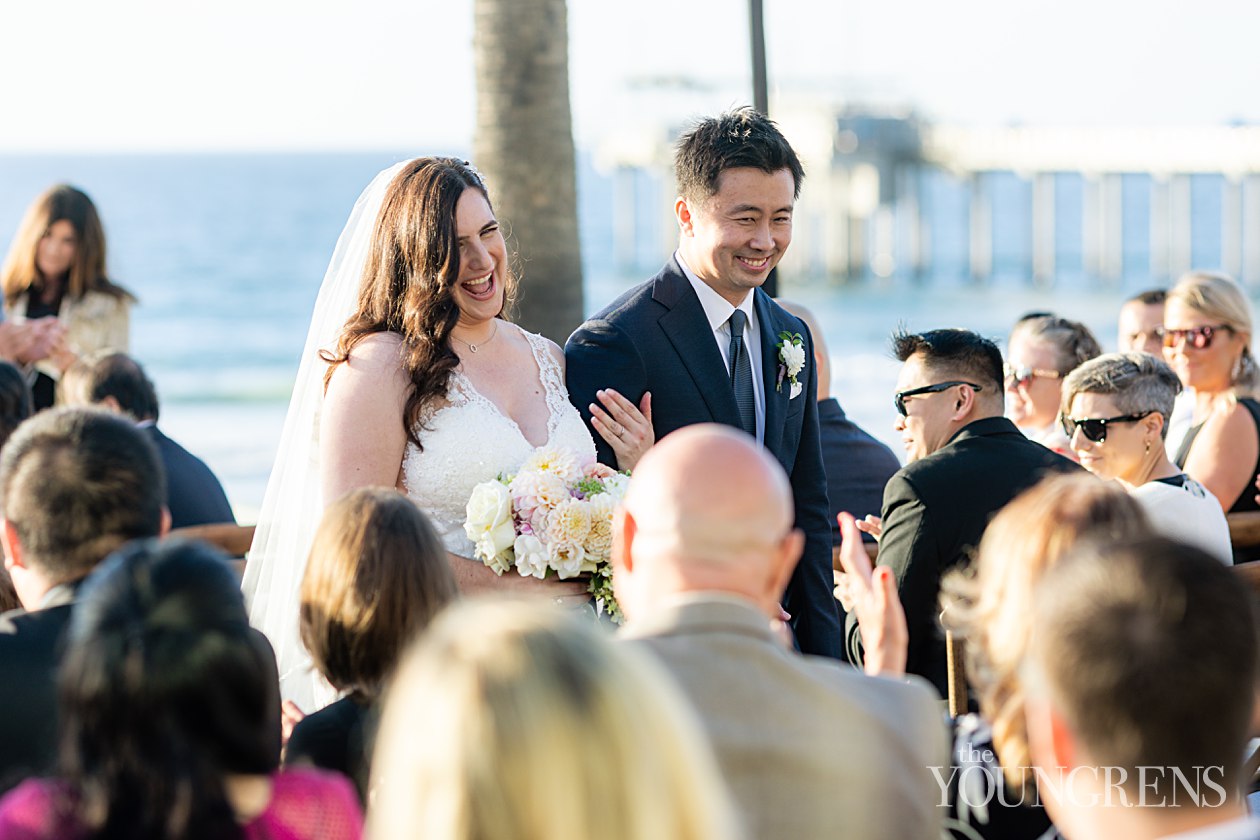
0;587;74;793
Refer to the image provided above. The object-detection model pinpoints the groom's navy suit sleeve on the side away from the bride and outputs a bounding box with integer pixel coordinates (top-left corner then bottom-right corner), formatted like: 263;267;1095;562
784;331;844;659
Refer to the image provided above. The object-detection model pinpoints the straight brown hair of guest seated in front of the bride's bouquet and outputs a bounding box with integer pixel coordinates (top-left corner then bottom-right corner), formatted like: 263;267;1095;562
300;487;456;700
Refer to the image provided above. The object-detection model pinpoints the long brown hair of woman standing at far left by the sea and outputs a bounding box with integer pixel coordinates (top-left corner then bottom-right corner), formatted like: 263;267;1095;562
0;184;135;306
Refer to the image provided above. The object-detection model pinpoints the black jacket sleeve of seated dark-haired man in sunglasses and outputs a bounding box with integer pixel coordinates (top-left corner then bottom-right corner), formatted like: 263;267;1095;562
878;472;940;683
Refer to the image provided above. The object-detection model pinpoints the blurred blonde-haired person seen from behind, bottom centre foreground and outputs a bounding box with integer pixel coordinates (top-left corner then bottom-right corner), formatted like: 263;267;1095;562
368;601;740;840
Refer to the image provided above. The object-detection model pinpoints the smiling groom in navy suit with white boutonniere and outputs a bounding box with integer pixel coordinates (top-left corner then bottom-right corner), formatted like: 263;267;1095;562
564;108;843;657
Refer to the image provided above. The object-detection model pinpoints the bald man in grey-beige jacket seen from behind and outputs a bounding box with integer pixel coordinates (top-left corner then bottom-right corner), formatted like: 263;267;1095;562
612;424;948;840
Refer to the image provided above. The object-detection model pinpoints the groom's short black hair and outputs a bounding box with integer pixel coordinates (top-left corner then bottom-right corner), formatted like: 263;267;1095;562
674;107;805;200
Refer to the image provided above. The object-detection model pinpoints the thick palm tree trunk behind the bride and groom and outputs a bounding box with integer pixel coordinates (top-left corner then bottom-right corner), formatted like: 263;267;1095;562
473;0;583;344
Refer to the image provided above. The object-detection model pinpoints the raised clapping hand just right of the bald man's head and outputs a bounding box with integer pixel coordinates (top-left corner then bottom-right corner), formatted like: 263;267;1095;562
835;513;910;675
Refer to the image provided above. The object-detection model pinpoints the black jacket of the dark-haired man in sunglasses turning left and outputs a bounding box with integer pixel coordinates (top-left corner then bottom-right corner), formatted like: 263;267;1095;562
848;417;1081;696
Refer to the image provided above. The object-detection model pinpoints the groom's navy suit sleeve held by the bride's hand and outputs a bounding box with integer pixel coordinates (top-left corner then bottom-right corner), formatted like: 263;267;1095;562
564;320;648;467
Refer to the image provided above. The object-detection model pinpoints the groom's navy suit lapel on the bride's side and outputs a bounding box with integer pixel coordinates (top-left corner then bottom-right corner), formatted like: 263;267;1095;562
651;261;740;426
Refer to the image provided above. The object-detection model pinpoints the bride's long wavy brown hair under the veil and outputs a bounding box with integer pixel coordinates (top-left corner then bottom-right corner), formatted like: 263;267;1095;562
320;157;517;446
